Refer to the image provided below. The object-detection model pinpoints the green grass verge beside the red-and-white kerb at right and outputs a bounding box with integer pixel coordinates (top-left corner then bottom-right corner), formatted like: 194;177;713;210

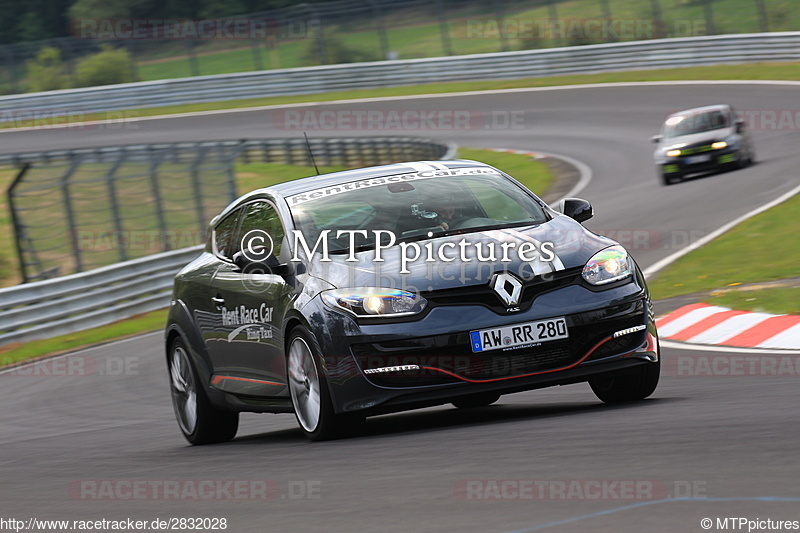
650;191;800;313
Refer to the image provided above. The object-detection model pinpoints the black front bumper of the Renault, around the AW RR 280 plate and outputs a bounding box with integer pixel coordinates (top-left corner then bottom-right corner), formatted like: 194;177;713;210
311;280;659;414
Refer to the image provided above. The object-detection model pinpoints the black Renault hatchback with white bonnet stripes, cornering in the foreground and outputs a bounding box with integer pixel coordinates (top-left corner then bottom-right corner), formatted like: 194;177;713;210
165;160;660;444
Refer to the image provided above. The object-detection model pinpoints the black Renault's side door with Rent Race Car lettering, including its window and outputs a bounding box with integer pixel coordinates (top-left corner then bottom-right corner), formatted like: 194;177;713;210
209;199;294;397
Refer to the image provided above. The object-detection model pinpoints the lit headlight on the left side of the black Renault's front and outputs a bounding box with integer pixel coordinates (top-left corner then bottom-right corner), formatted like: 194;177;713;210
322;287;428;317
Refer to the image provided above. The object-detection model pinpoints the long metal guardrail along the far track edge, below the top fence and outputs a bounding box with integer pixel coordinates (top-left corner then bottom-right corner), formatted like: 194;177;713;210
0;32;800;121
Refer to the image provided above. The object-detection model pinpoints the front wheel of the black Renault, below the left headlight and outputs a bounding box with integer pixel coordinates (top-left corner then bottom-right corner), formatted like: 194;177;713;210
286;326;365;441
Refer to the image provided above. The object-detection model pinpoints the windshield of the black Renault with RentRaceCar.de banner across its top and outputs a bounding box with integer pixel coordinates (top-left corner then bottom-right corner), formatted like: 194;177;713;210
287;169;547;253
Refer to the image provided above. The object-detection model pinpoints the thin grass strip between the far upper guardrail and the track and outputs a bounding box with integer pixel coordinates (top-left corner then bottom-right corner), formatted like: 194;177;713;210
0;63;800;129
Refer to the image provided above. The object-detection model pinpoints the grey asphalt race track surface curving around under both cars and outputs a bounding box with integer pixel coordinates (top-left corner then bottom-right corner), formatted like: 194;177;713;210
0;81;800;533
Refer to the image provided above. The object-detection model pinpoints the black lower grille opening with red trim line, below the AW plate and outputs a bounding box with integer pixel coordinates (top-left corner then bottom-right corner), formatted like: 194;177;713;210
351;300;645;387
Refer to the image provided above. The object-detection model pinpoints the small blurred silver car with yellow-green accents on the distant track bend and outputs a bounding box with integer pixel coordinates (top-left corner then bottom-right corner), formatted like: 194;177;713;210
652;105;755;185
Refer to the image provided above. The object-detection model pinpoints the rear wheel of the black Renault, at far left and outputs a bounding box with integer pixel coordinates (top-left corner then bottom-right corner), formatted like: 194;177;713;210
168;338;234;445
